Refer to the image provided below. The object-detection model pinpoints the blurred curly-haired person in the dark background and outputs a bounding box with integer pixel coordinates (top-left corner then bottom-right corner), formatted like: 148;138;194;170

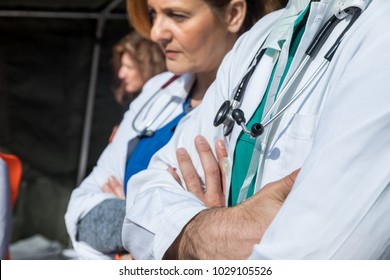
109;31;166;142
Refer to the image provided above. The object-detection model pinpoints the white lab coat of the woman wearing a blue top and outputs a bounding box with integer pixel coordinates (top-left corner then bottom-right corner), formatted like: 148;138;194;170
65;72;198;259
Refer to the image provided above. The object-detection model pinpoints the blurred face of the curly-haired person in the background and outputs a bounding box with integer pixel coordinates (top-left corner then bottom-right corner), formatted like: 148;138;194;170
118;53;144;93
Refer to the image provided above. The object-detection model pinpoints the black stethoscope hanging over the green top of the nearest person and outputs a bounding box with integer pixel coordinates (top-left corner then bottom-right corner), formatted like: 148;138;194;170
214;0;369;138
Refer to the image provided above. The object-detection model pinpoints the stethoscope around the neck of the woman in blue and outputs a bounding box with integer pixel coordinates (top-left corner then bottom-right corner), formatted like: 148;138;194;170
131;75;180;137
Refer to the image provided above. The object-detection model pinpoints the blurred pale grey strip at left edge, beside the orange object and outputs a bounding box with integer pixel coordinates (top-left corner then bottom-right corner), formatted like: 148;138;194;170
0;158;12;260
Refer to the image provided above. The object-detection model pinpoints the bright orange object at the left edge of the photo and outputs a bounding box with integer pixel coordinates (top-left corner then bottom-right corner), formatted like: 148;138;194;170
0;153;22;207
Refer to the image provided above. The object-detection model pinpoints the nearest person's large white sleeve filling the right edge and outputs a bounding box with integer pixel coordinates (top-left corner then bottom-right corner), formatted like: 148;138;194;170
250;5;390;259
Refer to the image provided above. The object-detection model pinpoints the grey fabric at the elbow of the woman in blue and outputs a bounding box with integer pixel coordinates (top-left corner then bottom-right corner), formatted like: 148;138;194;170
76;198;126;254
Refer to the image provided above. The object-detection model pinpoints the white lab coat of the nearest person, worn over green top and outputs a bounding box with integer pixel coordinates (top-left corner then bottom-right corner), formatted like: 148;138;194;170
122;0;390;259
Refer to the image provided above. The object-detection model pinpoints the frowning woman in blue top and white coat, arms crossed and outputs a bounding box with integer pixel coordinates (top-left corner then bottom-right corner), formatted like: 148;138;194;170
65;0;284;259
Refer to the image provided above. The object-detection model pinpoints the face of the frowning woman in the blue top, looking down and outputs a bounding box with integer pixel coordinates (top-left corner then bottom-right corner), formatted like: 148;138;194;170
148;0;232;74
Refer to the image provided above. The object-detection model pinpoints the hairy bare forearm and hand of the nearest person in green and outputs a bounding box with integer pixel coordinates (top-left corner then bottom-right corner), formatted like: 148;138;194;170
164;167;299;259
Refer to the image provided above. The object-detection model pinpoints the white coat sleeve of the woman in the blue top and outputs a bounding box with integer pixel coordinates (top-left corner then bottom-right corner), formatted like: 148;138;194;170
65;73;172;259
